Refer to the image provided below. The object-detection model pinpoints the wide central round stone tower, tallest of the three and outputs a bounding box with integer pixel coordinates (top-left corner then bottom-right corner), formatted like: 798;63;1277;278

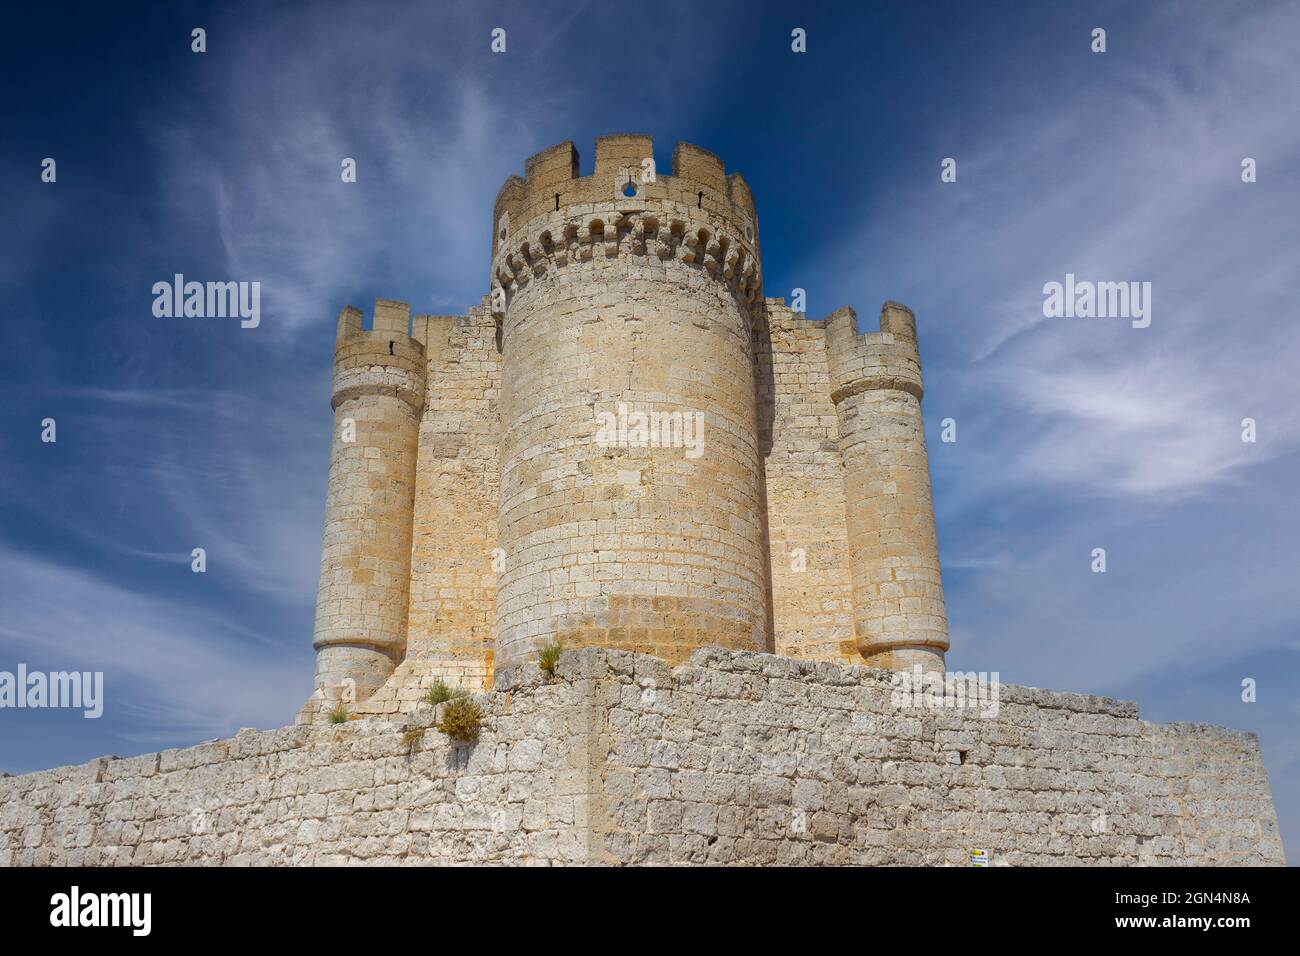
491;135;768;666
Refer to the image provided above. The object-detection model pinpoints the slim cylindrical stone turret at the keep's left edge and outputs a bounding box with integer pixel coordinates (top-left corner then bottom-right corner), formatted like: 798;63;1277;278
312;299;425;700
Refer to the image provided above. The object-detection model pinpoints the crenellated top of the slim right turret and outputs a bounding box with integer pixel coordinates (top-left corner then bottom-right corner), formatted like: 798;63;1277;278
826;302;923;405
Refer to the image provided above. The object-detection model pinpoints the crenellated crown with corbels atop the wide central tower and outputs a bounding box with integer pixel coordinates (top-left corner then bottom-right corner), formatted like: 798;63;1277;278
491;134;762;316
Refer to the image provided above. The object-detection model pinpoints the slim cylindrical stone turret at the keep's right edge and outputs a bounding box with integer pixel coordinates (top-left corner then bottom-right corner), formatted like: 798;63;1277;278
827;302;948;671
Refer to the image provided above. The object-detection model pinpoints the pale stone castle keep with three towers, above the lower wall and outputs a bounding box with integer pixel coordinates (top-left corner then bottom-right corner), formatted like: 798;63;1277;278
315;135;948;710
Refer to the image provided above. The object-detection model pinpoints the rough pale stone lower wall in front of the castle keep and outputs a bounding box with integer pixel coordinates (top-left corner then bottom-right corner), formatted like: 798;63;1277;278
0;648;1284;865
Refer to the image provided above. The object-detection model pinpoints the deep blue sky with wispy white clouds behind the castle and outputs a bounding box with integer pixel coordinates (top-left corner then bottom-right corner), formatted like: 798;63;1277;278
0;0;1300;860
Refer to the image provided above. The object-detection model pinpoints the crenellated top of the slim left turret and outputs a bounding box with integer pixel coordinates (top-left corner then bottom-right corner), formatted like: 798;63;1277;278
332;299;429;411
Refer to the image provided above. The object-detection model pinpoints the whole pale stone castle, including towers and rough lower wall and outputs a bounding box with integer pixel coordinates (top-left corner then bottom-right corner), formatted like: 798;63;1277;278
0;135;1286;866
